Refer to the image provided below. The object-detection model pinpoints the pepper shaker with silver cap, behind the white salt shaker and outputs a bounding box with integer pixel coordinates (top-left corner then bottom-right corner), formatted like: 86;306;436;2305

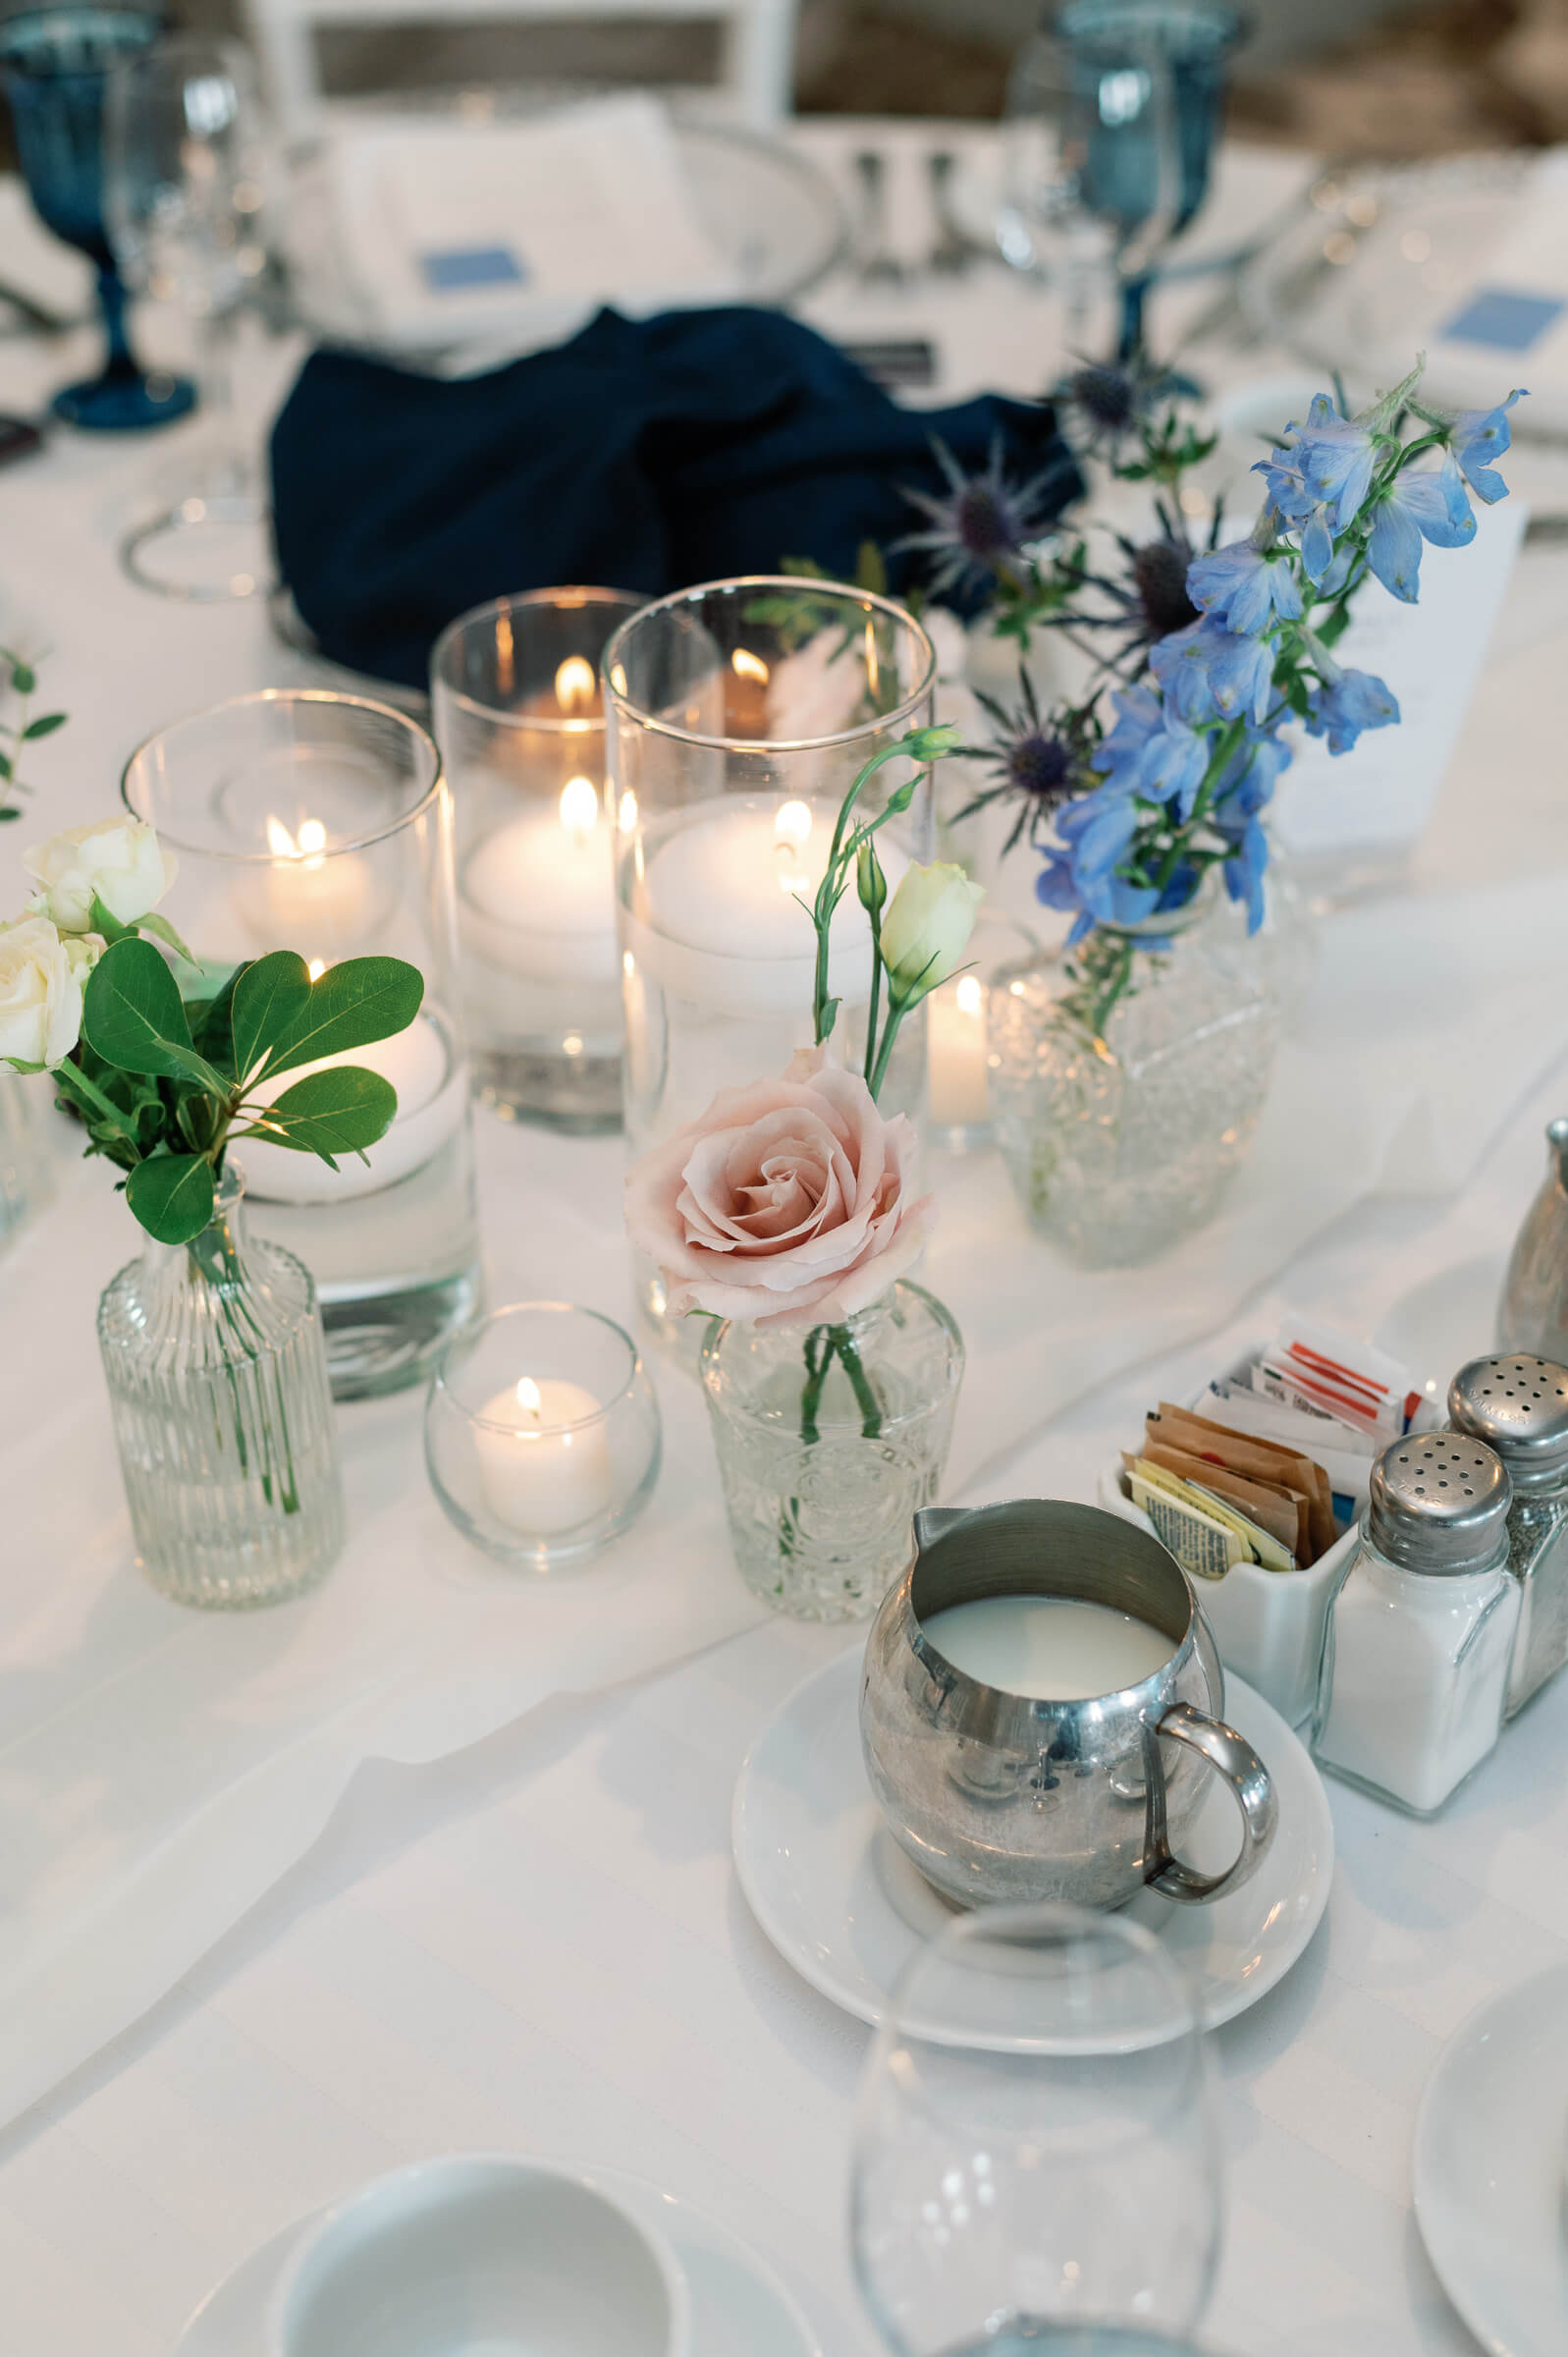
1448;1353;1568;1719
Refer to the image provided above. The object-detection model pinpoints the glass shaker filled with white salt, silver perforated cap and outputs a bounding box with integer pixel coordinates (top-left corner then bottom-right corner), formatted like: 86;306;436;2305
1311;1433;1519;1817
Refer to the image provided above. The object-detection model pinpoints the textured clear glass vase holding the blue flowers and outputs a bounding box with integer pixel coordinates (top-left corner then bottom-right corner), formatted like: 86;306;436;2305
988;894;1280;1268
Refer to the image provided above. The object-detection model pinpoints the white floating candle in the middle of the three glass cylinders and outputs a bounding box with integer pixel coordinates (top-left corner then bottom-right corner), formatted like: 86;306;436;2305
462;778;616;980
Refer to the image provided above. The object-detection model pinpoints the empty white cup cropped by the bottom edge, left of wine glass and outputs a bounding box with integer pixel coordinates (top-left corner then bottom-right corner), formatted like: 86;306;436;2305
266;2152;691;2357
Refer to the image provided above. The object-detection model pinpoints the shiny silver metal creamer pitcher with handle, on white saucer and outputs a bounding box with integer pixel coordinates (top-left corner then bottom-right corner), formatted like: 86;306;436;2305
861;1499;1275;1907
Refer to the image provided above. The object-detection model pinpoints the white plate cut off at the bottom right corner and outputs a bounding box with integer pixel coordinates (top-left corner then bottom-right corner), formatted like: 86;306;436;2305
1415;1963;1568;2357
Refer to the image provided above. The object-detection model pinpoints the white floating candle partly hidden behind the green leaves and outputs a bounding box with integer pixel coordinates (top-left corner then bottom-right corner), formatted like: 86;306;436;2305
236;1014;466;1202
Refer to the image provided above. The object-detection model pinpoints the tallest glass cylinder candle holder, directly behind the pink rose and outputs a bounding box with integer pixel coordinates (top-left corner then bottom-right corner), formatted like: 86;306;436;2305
604;576;936;1353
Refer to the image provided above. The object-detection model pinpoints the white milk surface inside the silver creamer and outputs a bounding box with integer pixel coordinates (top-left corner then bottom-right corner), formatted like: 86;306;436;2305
920;1596;1176;1702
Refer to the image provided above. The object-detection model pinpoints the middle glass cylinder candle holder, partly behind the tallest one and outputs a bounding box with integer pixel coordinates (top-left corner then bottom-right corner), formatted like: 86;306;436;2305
429;589;644;1133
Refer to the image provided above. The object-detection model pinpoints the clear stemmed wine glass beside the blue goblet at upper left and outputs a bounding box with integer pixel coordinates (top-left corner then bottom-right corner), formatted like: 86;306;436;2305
104;33;271;601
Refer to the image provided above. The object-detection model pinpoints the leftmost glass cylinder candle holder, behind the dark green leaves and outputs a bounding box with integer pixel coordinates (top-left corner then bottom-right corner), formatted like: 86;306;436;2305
123;688;479;1400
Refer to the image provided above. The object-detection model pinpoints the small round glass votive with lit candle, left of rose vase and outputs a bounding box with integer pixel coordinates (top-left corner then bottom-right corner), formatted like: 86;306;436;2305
424;1301;660;1572
